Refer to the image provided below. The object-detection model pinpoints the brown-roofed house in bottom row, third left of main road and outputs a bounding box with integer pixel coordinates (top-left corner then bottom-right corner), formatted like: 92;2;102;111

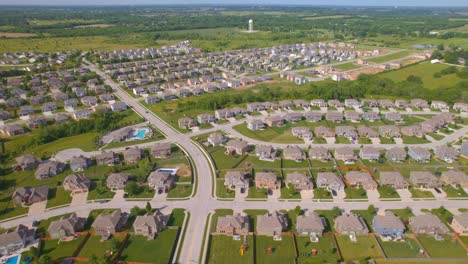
47;214;86;239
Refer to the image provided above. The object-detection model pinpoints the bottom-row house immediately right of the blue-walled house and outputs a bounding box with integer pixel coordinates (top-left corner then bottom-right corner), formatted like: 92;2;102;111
409;213;449;235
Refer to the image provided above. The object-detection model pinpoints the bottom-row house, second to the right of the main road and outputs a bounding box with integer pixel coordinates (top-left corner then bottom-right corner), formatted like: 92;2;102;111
257;211;288;238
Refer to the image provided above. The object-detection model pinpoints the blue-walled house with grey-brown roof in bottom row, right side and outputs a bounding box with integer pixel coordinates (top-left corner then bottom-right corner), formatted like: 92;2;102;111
372;211;406;238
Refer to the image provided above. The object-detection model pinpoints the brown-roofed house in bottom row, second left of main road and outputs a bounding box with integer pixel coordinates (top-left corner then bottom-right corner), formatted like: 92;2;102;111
91;209;128;238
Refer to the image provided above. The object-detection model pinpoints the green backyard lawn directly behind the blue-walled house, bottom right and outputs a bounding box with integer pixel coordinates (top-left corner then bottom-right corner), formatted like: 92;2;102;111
377;237;421;258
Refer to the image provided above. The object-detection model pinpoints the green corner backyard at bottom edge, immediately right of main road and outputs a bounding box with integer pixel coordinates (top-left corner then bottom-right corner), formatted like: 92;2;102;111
207;235;254;264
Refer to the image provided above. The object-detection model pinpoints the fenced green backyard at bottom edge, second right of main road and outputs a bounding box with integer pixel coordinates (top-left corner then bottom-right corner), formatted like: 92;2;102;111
255;235;295;264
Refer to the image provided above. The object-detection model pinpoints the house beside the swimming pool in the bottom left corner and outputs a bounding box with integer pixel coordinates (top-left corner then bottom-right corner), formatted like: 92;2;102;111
0;224;36;256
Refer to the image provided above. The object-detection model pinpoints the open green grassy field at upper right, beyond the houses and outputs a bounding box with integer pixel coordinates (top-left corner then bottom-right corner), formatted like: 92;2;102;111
380;62;462;89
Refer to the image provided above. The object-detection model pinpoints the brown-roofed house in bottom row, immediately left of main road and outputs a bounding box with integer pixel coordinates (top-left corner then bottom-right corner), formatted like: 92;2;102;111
133;210;168;240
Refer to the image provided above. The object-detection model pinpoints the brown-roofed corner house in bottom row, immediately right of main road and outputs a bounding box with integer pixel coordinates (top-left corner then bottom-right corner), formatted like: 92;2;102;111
216;214;250;236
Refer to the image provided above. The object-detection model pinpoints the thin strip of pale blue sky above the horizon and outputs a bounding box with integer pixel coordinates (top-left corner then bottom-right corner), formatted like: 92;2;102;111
0;0;468;7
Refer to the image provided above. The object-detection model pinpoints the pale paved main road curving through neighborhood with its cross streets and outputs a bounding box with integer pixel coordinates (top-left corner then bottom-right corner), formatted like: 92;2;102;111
0;58;468;263
